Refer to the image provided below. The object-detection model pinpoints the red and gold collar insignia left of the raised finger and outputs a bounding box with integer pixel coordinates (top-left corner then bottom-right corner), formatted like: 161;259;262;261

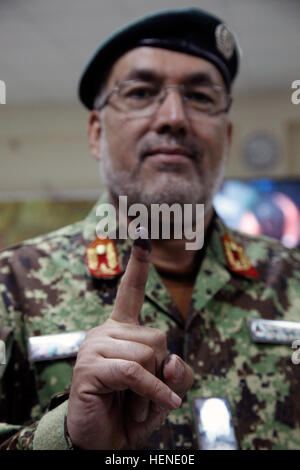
86;238;121;279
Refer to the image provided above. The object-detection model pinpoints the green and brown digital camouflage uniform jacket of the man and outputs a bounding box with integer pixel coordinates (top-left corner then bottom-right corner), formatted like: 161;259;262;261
0;196;300;449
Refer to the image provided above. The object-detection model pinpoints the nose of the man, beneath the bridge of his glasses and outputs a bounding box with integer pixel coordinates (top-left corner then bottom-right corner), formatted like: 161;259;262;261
153;86;188;135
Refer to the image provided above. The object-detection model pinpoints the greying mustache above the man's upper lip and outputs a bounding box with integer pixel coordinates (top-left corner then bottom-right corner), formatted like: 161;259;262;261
139;138;204;161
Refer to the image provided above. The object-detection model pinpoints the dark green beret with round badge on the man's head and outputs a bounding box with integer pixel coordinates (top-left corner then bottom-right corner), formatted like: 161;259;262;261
79;8;239;109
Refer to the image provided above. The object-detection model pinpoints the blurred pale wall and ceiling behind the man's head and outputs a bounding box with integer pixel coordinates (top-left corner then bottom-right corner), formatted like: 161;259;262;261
0;0;300;246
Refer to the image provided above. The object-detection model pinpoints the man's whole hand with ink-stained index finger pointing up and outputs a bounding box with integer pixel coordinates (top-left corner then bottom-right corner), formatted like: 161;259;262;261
67;231;193;450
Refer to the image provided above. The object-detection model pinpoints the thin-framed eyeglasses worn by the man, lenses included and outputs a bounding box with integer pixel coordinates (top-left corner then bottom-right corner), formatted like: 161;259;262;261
98;80;232;119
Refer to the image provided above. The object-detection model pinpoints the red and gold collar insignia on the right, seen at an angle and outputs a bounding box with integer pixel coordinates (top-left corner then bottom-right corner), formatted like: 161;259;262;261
222;234;259;279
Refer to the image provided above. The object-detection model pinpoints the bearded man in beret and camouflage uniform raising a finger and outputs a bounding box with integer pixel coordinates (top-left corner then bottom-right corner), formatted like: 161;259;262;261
0;6;300;449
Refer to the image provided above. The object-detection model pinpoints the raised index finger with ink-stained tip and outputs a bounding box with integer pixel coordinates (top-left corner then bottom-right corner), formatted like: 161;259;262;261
110;227;151;324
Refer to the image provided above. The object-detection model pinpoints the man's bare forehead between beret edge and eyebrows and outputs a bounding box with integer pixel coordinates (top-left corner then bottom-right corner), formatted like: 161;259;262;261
107;47;224;86
